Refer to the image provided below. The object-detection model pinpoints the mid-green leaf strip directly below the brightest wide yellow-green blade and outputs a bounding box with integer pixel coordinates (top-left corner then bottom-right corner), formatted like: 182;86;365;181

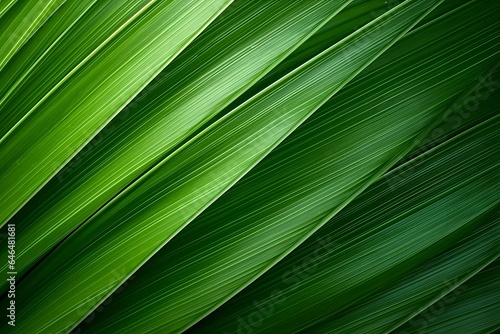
0;0;356;288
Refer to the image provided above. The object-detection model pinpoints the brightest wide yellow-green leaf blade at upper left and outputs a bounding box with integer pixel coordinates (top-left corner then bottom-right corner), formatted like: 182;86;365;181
0;0;231;222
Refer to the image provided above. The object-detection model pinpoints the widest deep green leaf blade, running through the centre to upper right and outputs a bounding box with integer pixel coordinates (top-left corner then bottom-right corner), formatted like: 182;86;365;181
75;1;498;332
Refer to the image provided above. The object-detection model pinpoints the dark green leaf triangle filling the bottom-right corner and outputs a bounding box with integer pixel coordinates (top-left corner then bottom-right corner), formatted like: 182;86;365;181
394;258;500;334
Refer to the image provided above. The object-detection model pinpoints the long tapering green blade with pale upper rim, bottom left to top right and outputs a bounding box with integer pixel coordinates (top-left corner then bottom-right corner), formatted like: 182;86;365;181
4;1;439;332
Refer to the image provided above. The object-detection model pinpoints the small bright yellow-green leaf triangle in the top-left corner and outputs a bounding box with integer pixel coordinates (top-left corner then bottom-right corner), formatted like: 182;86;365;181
0;0;66;71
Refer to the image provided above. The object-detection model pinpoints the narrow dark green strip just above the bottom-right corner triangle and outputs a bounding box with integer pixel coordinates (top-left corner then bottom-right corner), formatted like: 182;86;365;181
315;214;500;334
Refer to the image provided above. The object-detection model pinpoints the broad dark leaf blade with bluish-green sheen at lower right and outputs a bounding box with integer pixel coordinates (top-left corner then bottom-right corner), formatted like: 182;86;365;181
193;116;500;333
